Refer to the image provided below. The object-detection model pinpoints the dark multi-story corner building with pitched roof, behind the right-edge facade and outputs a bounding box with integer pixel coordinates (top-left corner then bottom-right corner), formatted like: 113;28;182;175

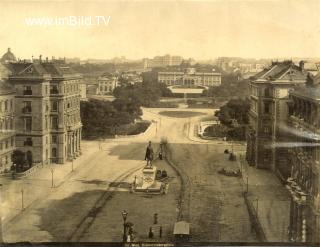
246;61;308;177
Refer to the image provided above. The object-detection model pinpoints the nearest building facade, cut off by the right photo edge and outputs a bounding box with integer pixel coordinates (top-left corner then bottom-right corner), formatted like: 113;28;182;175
286;78;320;242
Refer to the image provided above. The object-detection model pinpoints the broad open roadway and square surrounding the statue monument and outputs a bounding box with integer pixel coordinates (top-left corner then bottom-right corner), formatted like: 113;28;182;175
1;106;256;242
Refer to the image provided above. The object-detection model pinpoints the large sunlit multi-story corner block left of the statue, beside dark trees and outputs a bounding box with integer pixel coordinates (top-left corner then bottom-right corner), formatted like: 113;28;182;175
8;57;82;164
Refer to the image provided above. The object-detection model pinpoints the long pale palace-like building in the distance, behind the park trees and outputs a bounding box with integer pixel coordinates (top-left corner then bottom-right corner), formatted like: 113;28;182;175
158;68;221;87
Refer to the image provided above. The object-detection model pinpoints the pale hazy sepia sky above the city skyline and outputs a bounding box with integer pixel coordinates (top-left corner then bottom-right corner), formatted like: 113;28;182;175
0;0;320;60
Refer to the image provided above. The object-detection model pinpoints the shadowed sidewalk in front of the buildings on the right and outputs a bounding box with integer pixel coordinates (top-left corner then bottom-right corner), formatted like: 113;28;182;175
237;154;290;242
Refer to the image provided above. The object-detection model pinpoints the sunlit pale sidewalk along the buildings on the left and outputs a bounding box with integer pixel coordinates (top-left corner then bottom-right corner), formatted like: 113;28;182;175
0;141;99;227
